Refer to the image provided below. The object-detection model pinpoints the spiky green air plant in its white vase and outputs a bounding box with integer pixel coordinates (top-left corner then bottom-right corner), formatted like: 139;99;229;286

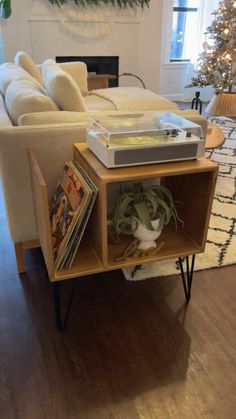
108;182;182;250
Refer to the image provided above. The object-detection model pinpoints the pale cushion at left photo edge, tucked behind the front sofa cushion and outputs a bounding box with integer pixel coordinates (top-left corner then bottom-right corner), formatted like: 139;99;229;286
0;63;32;96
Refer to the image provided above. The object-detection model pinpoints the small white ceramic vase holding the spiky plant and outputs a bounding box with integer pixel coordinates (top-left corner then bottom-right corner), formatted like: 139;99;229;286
133;218;161;250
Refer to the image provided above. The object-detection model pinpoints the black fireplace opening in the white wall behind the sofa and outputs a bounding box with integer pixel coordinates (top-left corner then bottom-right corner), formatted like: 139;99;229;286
56;56;119;87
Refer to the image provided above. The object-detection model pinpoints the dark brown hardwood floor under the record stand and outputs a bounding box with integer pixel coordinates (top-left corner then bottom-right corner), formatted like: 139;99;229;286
0;182;236;419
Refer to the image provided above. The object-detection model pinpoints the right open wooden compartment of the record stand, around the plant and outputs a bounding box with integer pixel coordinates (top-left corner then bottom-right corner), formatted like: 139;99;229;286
74;143;218;270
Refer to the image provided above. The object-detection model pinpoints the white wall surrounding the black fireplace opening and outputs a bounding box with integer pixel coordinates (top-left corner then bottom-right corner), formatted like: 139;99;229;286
2;0;163;92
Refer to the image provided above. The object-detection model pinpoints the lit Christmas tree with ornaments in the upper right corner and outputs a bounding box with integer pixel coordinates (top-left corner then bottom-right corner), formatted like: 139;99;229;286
191;0;236;94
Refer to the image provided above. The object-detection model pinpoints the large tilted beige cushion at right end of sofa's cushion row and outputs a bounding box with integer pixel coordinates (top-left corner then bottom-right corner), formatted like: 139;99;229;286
42;59;87;112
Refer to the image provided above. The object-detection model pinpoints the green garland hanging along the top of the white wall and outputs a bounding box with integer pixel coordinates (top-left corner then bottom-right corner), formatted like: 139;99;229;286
48;0;150;9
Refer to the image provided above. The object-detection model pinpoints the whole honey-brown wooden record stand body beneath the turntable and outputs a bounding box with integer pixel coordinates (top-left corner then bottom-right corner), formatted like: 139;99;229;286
29;143;218;281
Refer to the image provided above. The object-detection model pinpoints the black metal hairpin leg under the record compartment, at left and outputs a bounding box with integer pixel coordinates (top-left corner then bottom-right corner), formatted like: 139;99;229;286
53;281;76;332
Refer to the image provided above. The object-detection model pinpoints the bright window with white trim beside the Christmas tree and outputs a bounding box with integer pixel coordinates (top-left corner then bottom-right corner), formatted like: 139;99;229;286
170;0;200;62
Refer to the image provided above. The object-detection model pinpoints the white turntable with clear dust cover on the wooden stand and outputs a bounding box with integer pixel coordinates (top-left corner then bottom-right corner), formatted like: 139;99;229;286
86;111;205;168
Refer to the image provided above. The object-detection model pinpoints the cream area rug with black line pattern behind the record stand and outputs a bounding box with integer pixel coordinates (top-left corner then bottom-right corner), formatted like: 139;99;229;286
123;117;236;281
